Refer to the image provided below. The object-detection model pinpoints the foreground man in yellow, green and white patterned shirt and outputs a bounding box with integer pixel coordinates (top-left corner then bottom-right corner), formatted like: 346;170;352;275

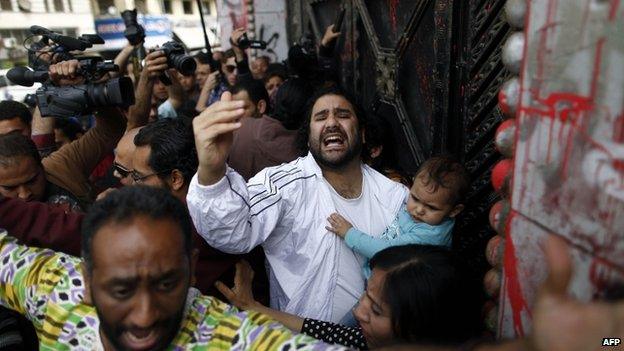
0;186;338;350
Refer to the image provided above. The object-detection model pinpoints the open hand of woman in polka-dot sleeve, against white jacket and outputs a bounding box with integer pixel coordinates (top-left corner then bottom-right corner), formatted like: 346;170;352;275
215;260;260;310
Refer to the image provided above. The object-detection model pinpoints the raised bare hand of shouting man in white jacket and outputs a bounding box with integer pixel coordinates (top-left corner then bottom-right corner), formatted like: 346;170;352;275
193;92;245;185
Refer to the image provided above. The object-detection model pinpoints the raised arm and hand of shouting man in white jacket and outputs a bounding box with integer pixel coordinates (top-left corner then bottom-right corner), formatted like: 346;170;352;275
186;92;286;253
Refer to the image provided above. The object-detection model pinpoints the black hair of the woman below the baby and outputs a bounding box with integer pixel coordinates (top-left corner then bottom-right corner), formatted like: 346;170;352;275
370;245;481;344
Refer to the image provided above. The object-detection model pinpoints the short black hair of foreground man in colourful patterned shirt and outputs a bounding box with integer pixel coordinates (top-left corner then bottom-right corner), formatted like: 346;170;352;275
81;185;193;271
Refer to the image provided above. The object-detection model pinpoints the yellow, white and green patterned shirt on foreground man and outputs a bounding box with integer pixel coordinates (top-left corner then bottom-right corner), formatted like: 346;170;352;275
0;229;342;350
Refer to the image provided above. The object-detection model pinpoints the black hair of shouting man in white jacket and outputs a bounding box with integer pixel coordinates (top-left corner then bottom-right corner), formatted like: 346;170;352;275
298;85;367;154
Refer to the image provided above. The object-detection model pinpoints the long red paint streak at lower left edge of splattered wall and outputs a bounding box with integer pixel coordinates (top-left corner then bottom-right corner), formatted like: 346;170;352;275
503;213;531;337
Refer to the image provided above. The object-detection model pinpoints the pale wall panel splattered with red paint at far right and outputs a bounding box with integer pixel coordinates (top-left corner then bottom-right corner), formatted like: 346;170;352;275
499;0;624;337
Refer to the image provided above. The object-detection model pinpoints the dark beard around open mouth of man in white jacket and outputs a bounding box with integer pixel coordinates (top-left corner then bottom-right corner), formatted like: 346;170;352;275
310;126;362;170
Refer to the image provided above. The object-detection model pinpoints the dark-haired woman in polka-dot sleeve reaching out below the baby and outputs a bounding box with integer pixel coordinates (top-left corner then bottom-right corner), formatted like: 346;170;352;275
217;245;481;349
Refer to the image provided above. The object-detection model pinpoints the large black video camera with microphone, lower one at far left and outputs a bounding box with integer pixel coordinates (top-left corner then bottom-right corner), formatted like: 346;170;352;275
7;57;134;118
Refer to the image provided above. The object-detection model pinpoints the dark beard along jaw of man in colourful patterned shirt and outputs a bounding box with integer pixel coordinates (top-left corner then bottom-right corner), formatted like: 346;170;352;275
91;296;186;351
